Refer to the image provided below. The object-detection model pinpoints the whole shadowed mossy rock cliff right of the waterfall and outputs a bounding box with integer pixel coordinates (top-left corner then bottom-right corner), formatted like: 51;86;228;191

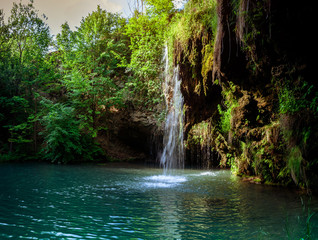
174;0;318;186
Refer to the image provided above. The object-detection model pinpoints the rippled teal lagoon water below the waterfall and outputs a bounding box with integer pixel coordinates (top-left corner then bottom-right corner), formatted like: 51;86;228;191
0;164;318;240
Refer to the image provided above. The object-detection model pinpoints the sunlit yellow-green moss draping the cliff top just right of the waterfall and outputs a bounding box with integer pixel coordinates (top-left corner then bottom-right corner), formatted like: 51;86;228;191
167;0;217;86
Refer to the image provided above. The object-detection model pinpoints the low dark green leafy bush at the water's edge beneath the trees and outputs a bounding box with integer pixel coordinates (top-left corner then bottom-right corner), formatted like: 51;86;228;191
40;101;100;163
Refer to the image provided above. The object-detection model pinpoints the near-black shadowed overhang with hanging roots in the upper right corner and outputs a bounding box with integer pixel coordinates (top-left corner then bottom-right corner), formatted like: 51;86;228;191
213;0;315;88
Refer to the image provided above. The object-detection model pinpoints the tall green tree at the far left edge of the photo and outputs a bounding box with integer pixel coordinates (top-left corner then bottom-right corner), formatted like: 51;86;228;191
0;1;51;159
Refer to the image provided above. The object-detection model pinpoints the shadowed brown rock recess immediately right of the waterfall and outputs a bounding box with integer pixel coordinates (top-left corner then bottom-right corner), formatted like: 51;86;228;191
175;40;222;168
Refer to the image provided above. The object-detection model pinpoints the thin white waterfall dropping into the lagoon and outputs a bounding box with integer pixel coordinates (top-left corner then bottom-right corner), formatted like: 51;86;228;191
160;47;184;173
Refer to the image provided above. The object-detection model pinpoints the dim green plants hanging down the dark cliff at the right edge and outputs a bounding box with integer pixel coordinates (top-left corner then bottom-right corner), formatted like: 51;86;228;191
276;77;318;188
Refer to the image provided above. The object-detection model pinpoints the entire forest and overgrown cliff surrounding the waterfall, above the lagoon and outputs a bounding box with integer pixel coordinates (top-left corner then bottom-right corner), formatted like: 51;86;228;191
0;0;318;191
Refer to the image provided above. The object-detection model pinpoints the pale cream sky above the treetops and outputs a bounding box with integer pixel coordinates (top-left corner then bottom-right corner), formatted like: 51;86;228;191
0;0;131;35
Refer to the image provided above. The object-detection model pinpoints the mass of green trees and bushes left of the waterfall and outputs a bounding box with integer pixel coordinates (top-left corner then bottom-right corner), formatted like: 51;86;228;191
0;0;174;162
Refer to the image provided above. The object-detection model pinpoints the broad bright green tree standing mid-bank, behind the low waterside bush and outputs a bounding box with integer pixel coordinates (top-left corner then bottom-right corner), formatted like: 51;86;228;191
57;6;129;137
